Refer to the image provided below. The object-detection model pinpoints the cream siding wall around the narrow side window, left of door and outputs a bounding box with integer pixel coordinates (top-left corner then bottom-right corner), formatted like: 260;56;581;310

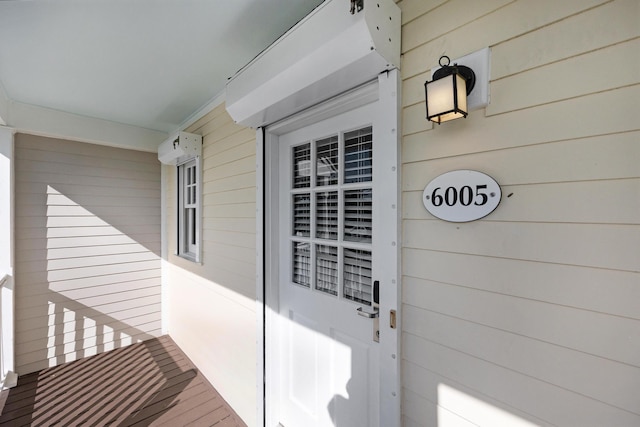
165;105;257;426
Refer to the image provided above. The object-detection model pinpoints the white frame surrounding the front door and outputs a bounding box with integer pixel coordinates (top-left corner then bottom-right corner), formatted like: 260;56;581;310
256;69;402;427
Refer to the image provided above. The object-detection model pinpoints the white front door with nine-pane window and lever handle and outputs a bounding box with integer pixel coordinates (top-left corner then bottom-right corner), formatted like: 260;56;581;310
267;73;399;427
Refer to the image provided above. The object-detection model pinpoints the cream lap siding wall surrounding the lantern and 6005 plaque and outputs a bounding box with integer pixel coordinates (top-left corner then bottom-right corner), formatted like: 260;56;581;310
399;0;640;427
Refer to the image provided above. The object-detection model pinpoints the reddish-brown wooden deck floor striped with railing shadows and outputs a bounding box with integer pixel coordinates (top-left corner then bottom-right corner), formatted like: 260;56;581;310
0;336;246;427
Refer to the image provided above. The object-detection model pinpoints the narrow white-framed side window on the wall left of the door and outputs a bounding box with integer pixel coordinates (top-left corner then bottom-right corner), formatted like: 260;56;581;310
177;156;201;262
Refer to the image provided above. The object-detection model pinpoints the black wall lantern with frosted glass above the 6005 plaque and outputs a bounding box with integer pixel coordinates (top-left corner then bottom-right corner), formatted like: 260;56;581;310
424;55;476;124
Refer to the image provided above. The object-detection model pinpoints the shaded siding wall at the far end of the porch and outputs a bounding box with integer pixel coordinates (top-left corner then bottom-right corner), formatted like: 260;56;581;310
15;134;160;374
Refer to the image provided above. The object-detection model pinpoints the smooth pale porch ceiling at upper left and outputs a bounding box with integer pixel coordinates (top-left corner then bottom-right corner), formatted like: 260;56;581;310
0;0;322;132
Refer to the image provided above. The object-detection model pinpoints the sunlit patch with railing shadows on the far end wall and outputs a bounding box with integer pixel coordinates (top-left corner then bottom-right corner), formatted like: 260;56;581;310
34;186;161;372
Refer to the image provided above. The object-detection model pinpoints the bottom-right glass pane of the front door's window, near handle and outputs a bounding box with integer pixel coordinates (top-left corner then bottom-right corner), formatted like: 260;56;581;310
344;248;371;305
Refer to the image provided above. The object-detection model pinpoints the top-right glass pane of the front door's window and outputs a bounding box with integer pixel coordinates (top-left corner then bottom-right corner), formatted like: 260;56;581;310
344;126;373;184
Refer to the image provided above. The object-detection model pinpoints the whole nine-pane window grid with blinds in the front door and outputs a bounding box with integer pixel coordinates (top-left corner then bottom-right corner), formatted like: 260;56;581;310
291;126;373;305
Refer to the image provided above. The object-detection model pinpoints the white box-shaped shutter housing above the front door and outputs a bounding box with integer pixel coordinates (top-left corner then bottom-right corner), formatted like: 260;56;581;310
226;0;400;128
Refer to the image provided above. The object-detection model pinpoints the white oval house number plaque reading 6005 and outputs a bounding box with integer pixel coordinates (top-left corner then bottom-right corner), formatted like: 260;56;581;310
422;170;502;222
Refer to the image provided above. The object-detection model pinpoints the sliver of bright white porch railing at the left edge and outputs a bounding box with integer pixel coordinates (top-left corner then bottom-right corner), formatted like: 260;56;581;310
0;274;18;390
